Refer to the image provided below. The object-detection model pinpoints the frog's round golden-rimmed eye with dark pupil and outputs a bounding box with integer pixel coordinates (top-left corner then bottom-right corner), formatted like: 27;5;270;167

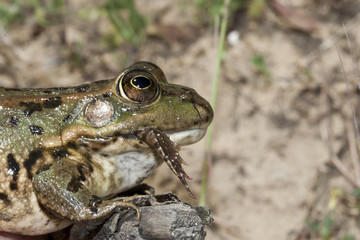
117;70;159;104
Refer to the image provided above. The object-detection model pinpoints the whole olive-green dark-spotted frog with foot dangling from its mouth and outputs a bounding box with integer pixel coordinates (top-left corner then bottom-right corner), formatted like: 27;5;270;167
0;62;213;235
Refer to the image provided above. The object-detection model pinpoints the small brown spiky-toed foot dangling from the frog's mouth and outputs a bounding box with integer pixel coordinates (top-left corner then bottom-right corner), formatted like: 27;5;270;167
137;129;196;199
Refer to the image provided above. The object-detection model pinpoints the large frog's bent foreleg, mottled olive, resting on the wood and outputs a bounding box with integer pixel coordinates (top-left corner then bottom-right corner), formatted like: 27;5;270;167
33;159;141;225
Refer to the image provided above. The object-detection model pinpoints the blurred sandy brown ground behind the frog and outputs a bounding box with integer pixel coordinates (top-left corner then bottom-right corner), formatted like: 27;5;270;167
0;0;360;240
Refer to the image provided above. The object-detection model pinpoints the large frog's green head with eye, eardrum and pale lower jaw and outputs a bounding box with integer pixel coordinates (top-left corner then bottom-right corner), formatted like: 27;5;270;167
77;62;213;145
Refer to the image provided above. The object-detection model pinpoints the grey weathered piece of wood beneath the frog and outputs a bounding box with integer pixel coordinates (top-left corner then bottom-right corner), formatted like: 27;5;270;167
52;193;213;240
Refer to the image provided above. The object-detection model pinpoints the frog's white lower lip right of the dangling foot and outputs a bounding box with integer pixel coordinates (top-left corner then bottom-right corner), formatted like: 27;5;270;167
166;128;206;145
